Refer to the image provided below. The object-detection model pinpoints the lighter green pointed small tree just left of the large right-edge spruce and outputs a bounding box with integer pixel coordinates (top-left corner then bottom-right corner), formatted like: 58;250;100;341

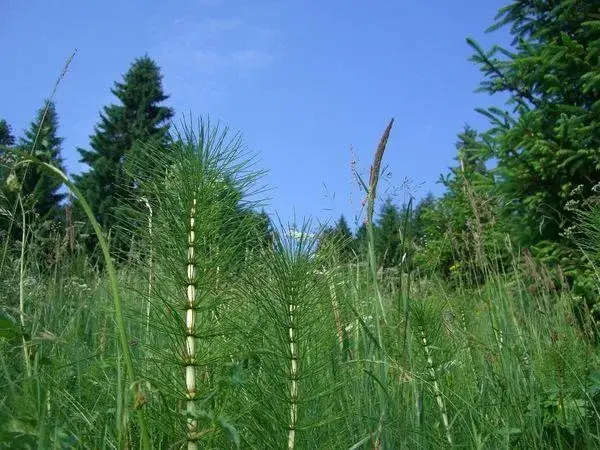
416;126;509;283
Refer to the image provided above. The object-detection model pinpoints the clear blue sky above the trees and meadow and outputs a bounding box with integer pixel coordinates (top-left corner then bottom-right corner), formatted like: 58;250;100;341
0;0;509;230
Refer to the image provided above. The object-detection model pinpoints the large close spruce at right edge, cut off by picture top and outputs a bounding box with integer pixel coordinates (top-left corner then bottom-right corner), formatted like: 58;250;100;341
469;0;600;267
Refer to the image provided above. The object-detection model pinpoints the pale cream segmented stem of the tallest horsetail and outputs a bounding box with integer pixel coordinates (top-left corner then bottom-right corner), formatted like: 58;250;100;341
184;198;198;450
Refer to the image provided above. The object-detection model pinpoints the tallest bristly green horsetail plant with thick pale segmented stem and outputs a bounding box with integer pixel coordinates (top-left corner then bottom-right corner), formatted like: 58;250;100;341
128;120;261;450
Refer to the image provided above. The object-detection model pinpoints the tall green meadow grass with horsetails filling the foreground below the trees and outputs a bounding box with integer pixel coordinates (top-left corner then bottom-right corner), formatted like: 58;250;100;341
0;118;600;449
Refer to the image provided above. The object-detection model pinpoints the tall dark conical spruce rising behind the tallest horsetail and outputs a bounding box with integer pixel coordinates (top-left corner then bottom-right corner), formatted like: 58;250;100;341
76;56;173;250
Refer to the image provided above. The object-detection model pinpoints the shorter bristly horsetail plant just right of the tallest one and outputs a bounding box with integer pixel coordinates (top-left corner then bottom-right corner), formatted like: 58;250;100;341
234;223;343;450
